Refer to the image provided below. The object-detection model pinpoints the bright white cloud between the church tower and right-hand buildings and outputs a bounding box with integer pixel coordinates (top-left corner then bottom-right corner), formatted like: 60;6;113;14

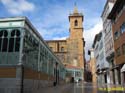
84;18;103;60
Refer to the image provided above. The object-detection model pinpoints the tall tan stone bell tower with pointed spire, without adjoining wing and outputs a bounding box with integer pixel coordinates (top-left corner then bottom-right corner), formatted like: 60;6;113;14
67;5;85;69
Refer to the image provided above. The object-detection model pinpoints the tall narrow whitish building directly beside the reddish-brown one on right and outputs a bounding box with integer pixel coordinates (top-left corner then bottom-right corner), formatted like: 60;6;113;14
101;0;116;84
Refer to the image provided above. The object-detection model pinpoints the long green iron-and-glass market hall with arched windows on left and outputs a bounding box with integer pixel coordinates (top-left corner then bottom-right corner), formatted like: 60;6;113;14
0;17;66;93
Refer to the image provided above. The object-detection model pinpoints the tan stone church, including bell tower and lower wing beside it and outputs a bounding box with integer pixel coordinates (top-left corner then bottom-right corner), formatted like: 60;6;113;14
46;6;85;80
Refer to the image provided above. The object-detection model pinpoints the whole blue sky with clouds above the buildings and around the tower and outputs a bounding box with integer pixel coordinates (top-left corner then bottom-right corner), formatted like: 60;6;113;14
0;0;106;60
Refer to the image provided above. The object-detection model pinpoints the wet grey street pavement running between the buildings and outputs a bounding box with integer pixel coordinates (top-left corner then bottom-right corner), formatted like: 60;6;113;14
38;83;125;93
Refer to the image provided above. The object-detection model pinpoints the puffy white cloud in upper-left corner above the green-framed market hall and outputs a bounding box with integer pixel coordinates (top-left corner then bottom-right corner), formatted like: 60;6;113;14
1;0;35;14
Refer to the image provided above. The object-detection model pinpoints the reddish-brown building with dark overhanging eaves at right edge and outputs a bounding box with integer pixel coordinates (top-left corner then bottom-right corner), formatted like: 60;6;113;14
108;0;125;85
